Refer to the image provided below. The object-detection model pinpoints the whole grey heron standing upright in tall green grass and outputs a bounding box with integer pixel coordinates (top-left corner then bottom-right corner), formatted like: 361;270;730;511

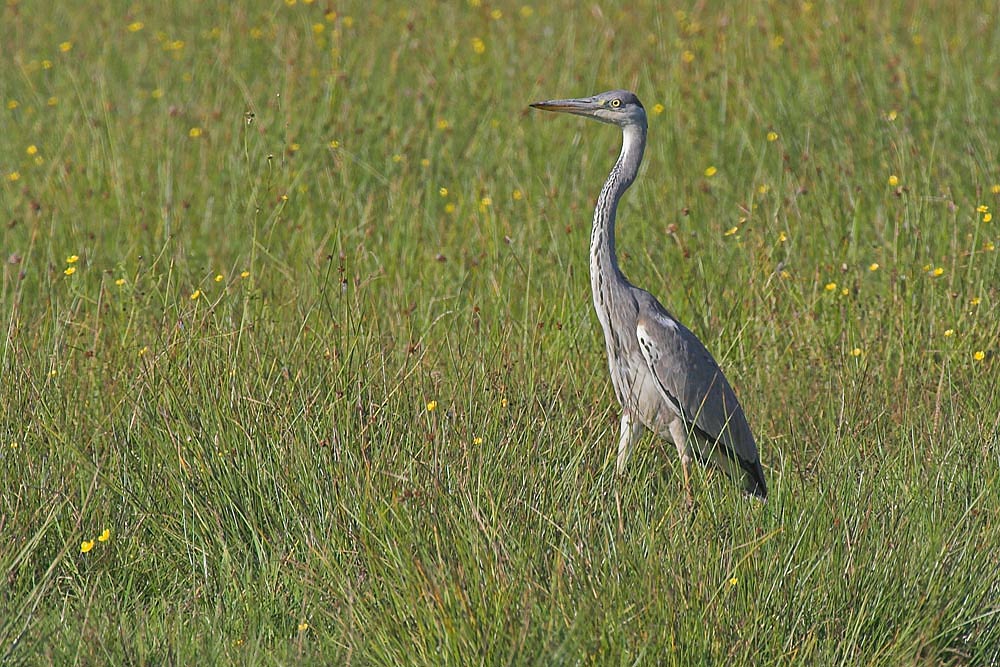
531;90;767;498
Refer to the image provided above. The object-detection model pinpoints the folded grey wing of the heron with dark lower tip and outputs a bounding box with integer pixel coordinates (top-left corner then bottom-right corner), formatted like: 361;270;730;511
636;296;763;485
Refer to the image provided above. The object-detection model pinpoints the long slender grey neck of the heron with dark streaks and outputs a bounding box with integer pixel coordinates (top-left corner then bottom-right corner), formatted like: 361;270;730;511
590;124;646;290
